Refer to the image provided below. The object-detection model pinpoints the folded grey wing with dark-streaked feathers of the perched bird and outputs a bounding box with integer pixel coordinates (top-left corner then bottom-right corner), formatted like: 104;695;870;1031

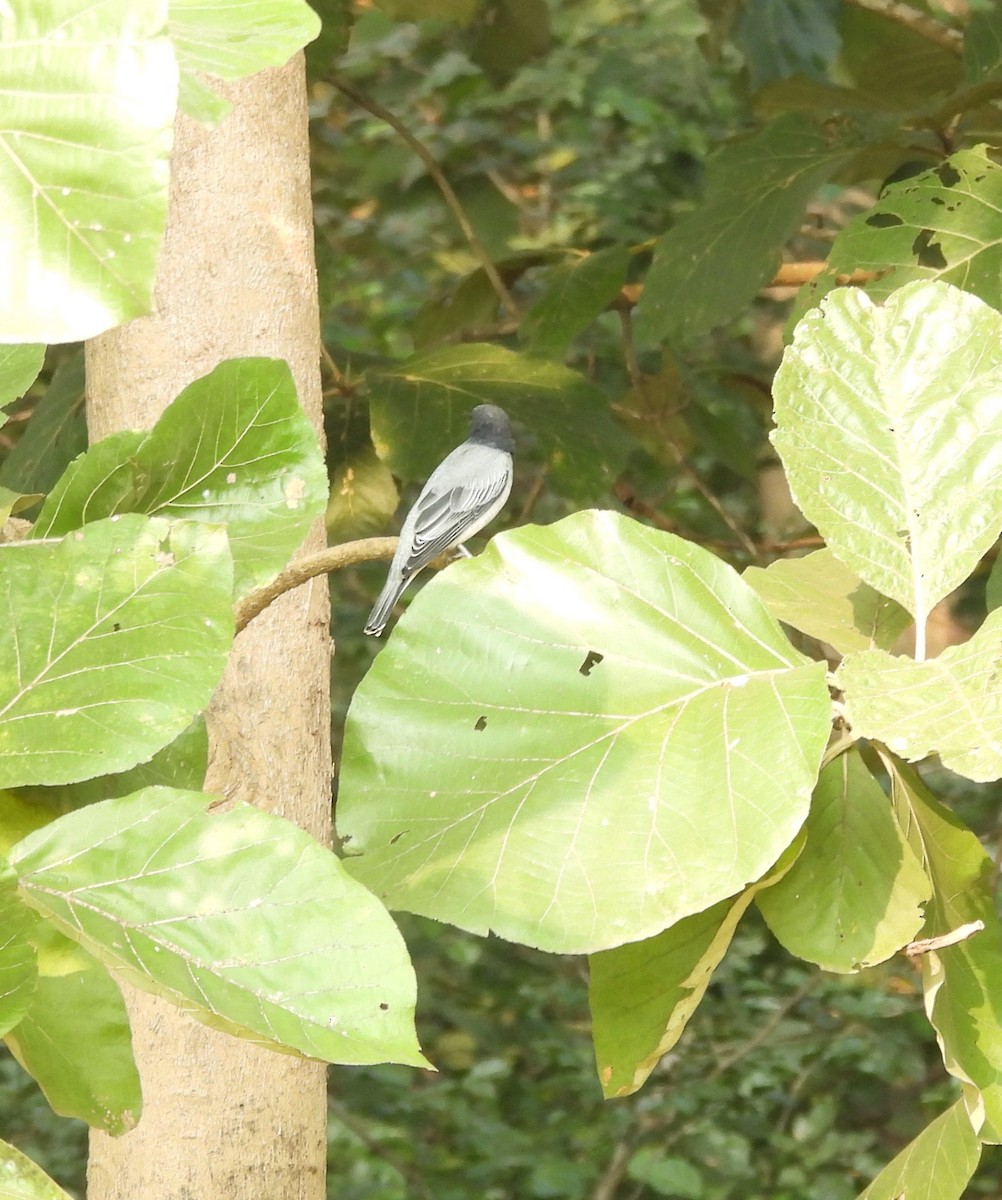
403;452;511;575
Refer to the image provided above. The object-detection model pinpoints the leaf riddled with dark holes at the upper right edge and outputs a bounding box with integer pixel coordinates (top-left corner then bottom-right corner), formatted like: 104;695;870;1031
798;146;1002;311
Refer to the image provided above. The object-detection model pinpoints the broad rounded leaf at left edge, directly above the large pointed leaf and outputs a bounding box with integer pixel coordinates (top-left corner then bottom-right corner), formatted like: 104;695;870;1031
0;516;233;787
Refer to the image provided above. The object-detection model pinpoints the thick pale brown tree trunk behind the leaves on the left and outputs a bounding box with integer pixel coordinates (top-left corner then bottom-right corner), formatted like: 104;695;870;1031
86;55;330;1200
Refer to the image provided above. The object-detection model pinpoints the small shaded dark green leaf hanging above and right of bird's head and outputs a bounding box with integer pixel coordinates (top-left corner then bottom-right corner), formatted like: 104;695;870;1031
518;246;630;358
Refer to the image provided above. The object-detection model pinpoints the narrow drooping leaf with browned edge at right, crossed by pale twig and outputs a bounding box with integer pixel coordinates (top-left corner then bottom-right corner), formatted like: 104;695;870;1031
887;757;1002;1142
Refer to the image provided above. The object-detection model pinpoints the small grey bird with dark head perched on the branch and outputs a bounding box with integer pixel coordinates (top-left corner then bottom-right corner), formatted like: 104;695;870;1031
365;404;515;637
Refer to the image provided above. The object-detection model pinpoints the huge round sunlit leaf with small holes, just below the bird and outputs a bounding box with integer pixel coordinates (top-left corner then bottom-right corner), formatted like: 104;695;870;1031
338;512;830;952
